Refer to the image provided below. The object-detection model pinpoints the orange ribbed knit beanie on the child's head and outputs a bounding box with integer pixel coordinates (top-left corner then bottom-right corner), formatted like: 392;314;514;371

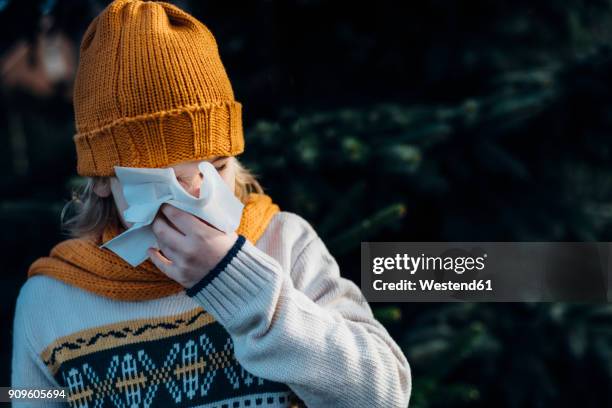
74;0;244;176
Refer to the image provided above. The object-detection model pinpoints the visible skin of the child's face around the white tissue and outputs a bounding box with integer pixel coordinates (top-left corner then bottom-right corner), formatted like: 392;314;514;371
95;156;236;228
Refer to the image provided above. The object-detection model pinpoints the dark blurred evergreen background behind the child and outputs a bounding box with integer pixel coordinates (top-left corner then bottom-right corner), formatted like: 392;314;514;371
0;0;612;408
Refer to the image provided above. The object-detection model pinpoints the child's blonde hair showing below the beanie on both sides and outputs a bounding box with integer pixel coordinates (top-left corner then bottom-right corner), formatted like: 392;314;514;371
61;156;263;238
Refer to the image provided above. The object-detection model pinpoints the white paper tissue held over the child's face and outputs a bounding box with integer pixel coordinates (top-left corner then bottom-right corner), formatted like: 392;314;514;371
100;161;244;266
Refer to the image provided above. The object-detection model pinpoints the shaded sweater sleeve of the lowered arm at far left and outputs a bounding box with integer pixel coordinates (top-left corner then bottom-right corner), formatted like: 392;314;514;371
11;291;67;408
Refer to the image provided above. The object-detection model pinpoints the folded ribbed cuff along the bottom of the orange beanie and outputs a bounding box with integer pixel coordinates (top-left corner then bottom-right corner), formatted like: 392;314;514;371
74;101;244;176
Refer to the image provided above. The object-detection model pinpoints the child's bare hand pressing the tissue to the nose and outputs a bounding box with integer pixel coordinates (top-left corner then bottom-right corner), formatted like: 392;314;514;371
148;204;238;288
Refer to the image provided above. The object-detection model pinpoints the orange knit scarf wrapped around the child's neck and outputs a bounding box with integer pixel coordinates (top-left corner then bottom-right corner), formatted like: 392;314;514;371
28;193;280;301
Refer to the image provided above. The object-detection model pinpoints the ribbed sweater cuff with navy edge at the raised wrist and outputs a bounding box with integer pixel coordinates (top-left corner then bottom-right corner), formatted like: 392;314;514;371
186;235;281;328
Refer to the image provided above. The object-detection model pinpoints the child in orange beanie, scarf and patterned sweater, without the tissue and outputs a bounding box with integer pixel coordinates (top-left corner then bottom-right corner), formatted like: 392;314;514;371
12;0;411;408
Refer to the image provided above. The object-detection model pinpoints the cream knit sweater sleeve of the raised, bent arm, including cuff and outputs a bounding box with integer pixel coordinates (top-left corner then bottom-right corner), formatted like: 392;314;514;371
188;236;411;408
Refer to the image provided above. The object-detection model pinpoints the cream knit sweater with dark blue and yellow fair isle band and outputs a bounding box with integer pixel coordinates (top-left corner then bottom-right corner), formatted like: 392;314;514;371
12;212;411;408
